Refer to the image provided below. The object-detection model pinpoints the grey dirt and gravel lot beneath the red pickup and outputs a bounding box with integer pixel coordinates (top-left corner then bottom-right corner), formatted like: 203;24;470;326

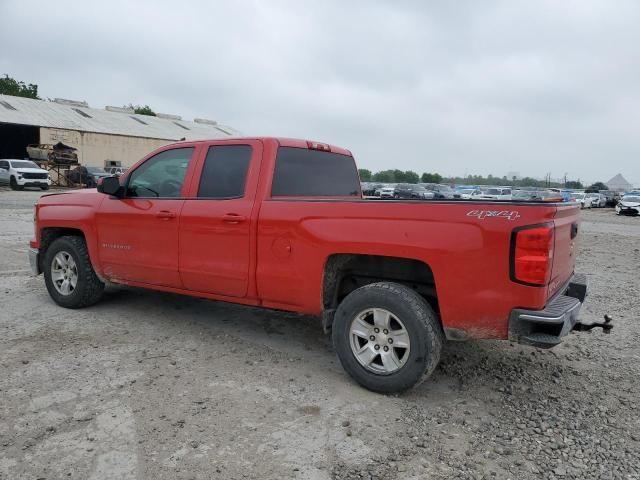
0;190;640;480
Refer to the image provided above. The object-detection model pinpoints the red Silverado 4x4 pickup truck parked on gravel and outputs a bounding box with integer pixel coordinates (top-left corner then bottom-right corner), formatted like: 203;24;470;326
29;138;587;392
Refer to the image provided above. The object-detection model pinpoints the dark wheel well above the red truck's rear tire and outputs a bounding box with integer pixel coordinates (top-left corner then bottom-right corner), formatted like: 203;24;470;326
323;254;440;329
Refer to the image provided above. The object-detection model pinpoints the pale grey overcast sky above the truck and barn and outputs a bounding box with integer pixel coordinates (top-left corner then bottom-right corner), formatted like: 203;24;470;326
0;0;640;185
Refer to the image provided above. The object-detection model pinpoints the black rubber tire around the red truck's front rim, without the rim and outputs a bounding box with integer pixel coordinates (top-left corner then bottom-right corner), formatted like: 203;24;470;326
42;236;104;308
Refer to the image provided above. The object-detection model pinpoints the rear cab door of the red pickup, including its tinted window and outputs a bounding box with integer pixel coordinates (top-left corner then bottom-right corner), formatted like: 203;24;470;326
179;140;262;297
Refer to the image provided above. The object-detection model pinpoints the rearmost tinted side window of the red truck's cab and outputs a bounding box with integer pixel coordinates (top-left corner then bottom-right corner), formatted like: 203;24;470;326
271;147;360;197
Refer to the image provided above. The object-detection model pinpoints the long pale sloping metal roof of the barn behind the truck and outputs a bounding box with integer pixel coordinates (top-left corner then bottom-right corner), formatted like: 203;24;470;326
0;95;239;140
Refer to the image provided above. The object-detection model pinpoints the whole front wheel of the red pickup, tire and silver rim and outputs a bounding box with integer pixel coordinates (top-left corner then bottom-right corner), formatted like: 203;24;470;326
43;236;104;308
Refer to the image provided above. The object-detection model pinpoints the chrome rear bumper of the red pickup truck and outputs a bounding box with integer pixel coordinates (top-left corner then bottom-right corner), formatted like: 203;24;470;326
509;274;588;348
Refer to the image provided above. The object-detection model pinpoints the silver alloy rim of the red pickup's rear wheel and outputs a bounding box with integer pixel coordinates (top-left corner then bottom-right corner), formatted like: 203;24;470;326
349;308;411;375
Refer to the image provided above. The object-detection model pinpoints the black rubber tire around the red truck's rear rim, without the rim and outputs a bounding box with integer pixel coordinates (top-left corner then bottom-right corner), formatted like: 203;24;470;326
332;282;443;393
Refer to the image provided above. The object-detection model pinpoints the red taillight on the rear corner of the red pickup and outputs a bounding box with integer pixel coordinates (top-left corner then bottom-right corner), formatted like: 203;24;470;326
511;225;553;286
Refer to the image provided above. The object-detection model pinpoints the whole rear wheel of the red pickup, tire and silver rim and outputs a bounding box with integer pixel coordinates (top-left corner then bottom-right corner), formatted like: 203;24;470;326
333;282;443;393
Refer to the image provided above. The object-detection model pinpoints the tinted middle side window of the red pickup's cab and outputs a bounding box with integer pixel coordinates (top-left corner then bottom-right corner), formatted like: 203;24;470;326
198;145;251;198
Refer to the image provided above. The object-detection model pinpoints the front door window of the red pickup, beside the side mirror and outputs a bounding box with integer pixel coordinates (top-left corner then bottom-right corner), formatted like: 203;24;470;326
127;147;193;198
